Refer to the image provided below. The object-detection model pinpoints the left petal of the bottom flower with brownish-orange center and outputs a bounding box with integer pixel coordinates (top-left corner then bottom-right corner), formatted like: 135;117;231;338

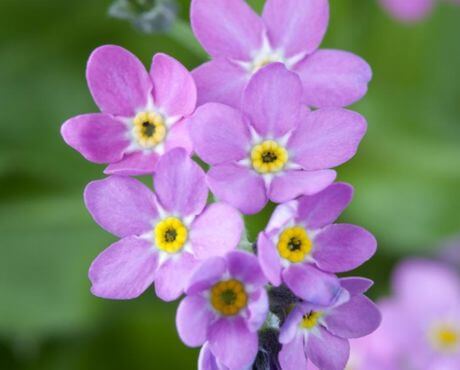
176;295;215;347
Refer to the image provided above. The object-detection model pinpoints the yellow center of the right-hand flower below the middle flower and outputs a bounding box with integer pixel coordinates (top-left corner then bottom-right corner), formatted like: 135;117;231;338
277;226;313;263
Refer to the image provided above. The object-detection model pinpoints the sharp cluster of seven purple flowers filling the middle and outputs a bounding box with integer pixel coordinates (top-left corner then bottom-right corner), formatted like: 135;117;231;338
62;0;380;370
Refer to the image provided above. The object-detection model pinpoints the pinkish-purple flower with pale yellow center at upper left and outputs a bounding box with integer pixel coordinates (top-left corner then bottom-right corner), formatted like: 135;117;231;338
61;45;197;175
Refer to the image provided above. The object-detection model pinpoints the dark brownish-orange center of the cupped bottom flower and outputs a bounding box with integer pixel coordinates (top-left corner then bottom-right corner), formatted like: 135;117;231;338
211;279;248;316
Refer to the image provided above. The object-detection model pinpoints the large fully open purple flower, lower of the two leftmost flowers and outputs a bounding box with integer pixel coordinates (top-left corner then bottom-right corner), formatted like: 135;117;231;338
85;148;243;301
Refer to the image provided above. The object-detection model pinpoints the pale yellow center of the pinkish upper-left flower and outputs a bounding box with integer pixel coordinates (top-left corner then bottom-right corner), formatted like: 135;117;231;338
133;112;166;149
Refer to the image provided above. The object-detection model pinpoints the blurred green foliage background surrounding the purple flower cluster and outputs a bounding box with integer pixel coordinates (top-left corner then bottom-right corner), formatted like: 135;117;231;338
0;0;460;370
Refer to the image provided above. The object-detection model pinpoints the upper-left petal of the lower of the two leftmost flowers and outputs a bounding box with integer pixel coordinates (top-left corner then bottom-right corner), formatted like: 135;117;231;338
84;176;158;237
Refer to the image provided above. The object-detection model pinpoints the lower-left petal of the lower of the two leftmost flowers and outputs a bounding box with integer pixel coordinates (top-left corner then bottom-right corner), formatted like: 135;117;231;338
89;237;158;299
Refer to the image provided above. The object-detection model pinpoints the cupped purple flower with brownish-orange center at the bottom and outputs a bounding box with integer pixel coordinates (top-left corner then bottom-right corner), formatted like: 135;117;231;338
176;251;268;369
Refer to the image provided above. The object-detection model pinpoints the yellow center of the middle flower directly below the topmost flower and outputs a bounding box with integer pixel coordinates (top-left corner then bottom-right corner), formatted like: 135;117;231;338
251;140;289;173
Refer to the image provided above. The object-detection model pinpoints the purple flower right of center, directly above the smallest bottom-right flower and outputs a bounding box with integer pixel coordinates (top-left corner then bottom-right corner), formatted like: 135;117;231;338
257;183;377;305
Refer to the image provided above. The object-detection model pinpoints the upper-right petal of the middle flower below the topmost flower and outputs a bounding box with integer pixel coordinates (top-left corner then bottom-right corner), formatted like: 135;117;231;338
287;108;367;170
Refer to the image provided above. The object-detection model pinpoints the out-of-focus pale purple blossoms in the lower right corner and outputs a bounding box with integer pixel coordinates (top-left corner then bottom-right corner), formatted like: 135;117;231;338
349;259;460;370
